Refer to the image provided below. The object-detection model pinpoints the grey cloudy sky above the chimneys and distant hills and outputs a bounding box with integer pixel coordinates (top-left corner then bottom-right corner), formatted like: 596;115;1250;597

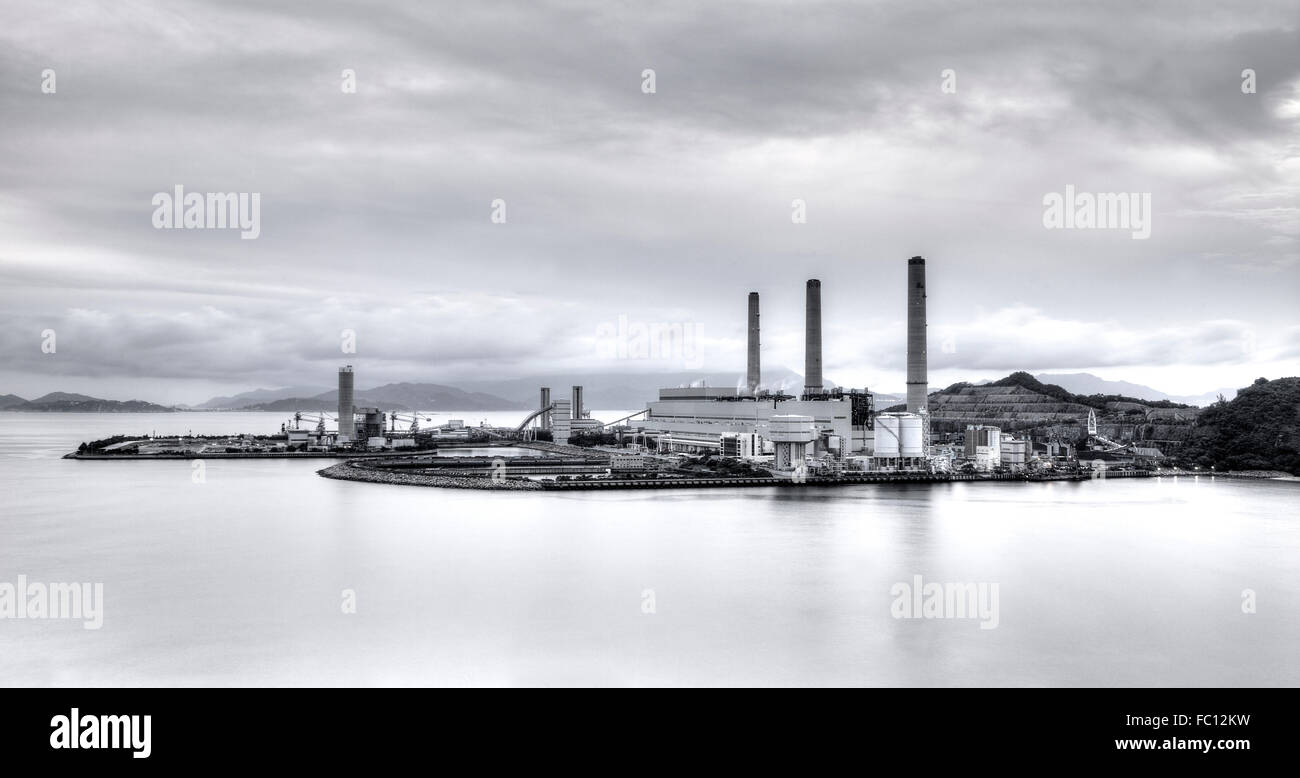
0;0;1300;403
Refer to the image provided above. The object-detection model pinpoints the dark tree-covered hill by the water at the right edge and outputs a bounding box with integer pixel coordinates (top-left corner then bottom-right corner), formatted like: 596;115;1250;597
1180;377;1300;475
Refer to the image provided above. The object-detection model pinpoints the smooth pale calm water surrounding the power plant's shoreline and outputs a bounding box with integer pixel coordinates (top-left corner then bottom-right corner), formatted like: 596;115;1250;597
0;412;1300;686
